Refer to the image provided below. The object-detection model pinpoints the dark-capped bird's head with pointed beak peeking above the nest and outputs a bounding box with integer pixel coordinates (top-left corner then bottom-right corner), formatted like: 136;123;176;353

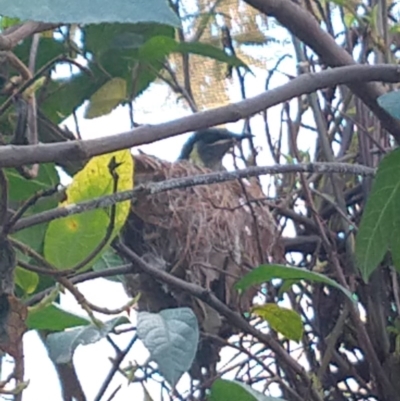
179;128;251;170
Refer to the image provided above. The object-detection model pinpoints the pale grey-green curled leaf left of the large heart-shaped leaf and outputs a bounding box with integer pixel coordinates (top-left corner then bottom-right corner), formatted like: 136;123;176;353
46;316;129;363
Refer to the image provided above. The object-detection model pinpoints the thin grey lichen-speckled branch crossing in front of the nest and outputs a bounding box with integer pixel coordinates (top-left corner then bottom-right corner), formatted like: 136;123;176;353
12;163;375;232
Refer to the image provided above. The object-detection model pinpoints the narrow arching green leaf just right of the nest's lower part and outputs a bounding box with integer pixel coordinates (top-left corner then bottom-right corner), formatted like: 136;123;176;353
235;265;354;302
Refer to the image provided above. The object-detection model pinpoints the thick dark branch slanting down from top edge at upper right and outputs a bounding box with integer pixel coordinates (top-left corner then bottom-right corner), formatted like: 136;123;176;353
245;0;400;143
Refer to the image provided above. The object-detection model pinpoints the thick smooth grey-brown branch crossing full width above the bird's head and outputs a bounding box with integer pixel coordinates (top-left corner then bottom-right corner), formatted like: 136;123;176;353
0;65;400;167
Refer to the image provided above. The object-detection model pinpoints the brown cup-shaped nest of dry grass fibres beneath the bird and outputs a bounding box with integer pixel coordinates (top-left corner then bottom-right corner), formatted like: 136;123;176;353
123;154;280;376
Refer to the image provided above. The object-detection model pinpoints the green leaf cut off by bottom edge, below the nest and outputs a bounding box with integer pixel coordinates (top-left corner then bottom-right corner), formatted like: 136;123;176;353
209;379;285;401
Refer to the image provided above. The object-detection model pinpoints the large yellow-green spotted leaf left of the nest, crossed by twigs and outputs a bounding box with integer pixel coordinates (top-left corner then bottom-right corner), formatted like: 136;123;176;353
44;150;133;270
